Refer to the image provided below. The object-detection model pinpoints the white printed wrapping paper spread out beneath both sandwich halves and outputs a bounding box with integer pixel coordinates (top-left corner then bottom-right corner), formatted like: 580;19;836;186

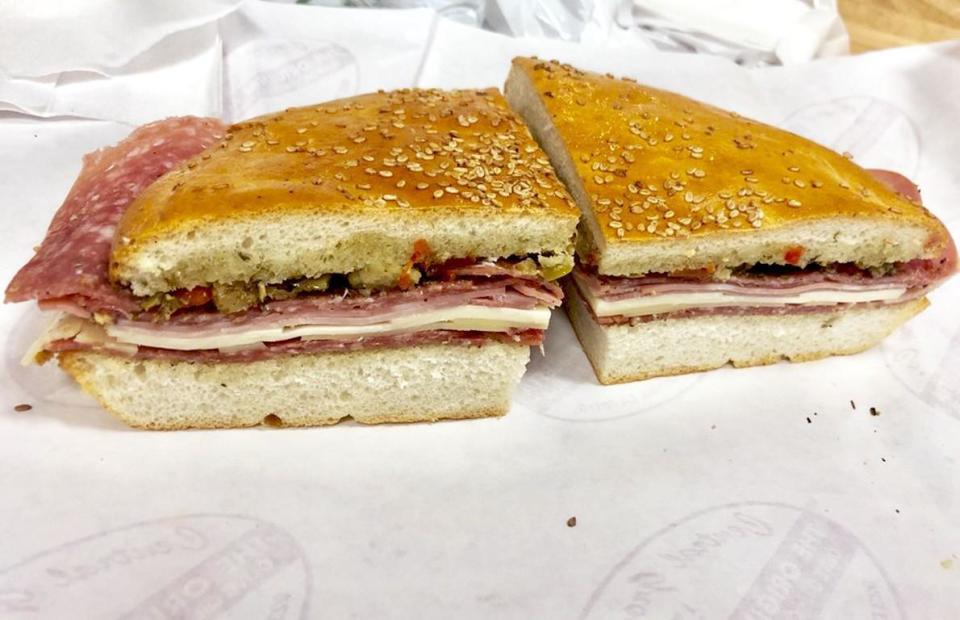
0;7;960;618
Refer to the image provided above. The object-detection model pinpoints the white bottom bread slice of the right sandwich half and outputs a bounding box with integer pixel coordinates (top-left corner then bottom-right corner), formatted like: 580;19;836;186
563;284;928;384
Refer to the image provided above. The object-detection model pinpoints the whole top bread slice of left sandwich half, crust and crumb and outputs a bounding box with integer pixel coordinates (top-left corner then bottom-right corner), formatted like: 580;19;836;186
110;89;579;296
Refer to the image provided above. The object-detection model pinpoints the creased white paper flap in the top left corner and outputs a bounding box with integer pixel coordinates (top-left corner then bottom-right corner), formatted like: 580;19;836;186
0;0;242;125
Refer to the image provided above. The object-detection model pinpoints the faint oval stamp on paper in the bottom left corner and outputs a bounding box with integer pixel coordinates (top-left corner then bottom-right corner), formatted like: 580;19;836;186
0;515;311;620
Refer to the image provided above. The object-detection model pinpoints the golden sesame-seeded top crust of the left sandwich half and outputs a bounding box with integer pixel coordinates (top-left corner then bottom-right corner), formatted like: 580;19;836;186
111;89;579;277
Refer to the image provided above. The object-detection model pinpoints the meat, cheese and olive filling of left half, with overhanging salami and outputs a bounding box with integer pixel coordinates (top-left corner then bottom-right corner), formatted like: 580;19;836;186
6;118;562;362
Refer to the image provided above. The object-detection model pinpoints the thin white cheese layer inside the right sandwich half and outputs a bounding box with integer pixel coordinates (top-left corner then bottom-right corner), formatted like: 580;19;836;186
577;285;907;317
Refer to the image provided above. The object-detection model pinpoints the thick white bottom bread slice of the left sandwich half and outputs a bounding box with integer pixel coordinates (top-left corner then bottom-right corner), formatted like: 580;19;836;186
59;341;530;430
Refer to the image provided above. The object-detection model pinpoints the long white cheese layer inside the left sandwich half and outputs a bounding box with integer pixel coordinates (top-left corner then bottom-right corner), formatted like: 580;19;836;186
106;305;550;351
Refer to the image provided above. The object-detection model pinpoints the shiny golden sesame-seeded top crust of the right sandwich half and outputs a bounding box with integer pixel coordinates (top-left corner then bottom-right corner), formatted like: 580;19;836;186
513;58;949;254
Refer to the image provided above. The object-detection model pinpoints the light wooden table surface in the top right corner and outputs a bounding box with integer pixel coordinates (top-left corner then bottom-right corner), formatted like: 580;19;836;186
839;0;960;52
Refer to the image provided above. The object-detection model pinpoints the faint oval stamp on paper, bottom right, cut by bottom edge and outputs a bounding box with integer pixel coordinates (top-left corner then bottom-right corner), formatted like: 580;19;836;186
580;503;904;620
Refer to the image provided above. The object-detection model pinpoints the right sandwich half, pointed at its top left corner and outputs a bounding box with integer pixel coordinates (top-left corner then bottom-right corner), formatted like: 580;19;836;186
506;58;956;383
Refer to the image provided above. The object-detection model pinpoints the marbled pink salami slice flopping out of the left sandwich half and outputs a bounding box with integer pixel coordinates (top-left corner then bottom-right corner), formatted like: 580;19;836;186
6;117;226;313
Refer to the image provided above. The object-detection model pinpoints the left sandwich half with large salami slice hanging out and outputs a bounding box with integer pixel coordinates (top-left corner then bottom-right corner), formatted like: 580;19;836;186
6;89;578;429
